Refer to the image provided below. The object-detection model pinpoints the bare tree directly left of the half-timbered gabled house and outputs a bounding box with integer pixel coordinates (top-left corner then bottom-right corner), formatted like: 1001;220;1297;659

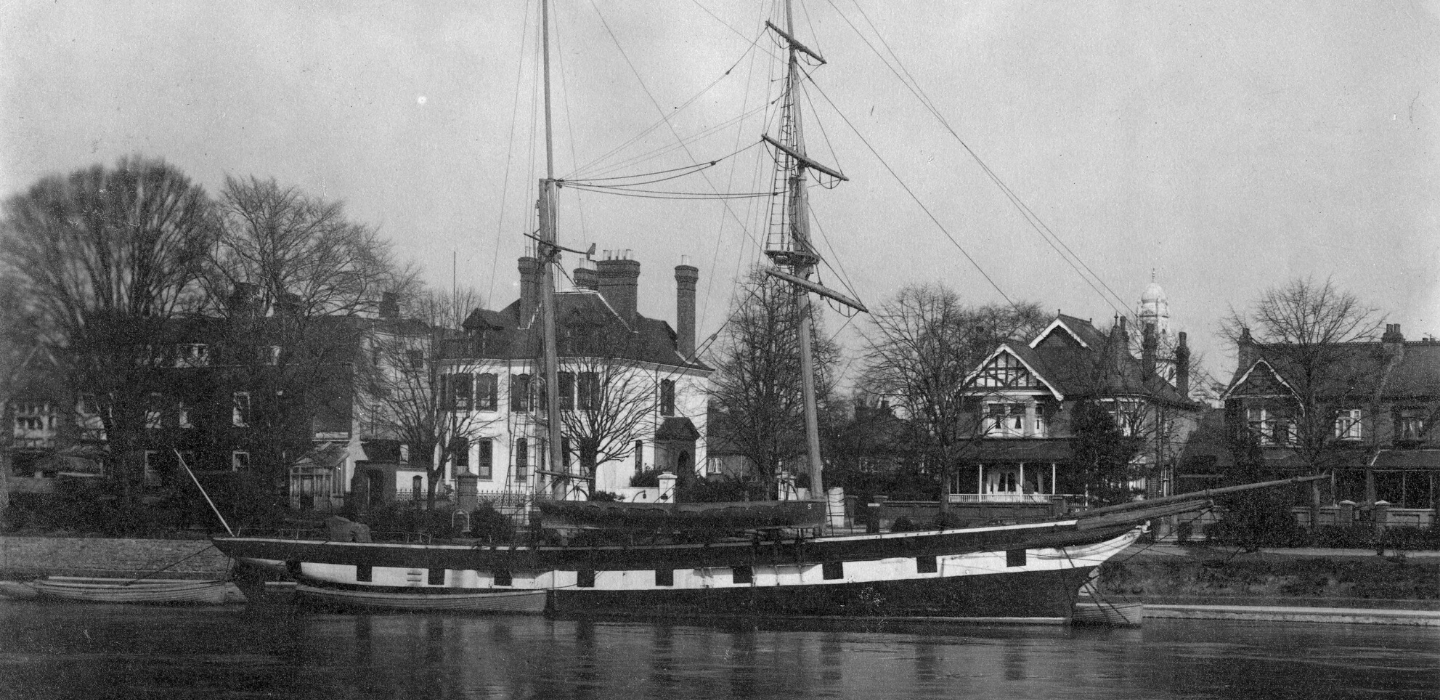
863;284;1045;513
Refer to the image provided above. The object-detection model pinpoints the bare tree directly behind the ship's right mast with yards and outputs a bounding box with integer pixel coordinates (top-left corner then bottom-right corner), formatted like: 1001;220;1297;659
710;269;840;497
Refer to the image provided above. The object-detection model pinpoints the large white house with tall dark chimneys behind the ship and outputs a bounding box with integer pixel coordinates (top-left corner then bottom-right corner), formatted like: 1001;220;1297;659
444;253;711;500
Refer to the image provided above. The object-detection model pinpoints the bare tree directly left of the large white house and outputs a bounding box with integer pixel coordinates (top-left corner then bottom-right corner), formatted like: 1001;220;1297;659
360;288;494;510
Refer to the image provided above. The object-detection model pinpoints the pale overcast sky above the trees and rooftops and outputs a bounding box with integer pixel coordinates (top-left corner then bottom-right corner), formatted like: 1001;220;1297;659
0;0;1440;391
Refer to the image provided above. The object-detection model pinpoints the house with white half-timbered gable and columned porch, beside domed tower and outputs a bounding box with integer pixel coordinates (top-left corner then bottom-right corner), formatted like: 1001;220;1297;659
949;314;1201;506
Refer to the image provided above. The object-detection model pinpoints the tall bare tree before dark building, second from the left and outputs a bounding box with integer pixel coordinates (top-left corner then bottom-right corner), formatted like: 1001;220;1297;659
204;177;416;504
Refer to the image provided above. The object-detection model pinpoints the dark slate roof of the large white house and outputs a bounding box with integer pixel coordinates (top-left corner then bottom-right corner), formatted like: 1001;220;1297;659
445;290;710;372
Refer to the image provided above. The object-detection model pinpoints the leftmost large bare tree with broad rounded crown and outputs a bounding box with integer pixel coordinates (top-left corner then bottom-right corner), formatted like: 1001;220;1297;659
0;157;219;508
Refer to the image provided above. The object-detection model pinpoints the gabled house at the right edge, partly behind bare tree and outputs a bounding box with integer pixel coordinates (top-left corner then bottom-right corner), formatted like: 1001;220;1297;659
1217;324;1440;527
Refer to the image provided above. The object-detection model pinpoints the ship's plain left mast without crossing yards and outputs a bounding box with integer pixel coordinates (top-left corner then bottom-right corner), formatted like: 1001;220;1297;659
536;0;567;494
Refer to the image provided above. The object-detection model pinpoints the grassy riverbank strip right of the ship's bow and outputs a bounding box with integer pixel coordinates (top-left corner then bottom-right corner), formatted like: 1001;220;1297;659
1100;549;1440;606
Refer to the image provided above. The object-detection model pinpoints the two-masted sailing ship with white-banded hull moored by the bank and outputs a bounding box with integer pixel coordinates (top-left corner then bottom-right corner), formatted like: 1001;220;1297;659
215;3;1319;622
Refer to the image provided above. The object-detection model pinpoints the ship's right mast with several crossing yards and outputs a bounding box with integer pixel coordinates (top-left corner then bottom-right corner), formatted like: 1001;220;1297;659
763;0;864;498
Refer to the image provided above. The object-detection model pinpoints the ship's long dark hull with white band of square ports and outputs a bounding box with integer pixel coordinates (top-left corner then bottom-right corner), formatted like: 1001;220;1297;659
216;521;1140;622
